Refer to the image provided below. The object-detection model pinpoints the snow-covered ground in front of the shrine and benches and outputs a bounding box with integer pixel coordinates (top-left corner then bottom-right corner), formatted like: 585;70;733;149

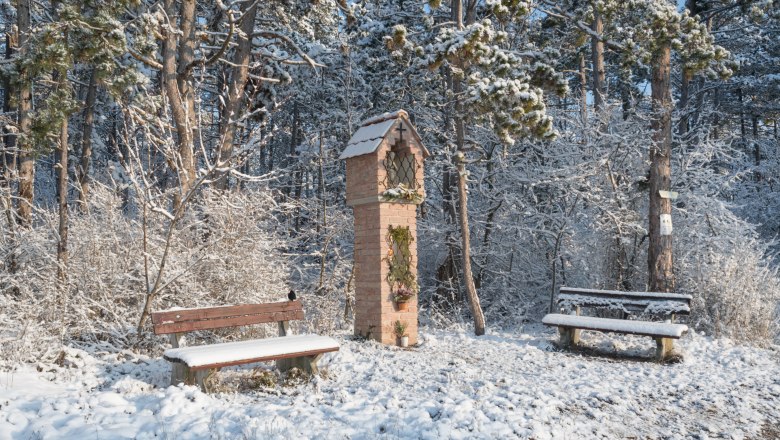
0;328;780;439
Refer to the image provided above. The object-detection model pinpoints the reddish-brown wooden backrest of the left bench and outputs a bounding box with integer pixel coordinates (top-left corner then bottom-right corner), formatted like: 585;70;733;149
152;301;303;335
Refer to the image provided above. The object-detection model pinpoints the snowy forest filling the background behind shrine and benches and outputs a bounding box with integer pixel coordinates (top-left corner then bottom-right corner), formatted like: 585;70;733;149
0;0;780;374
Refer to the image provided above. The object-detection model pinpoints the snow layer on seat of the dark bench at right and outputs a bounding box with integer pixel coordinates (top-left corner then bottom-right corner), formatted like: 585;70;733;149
542;313;688;339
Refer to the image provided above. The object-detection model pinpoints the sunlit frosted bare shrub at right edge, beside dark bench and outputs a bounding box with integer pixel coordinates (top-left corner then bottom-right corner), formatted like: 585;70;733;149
677;195;780;344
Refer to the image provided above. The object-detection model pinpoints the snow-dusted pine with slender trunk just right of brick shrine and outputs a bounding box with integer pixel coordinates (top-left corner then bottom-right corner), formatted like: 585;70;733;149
390;0;567;335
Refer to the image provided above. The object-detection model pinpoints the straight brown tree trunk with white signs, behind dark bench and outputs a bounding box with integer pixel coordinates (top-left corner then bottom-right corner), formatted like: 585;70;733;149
647;43;674;292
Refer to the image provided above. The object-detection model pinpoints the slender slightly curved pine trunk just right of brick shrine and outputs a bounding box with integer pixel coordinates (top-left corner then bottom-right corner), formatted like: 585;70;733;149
452;0;485;336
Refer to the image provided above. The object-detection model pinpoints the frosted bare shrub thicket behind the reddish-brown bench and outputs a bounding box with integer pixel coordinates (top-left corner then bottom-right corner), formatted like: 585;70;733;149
0;185;345;365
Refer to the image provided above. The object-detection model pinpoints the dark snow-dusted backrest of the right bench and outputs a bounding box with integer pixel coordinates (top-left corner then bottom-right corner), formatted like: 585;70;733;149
558;287;692;316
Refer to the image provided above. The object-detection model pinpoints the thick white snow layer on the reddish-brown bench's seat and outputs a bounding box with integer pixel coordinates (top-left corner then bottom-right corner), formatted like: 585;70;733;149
165;335;339;367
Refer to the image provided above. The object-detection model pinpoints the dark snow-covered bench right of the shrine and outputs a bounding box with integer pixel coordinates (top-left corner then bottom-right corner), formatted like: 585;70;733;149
542;287;691;361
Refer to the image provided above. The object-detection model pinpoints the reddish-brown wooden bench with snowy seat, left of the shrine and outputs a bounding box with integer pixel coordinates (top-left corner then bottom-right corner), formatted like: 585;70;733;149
152;301;339;391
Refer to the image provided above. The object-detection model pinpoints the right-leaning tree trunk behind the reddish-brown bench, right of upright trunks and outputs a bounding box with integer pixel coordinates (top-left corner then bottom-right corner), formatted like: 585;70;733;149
216;2;257;191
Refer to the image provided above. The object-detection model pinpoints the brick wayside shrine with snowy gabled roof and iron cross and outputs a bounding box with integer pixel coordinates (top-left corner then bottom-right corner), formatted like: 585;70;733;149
339;110;430;345
